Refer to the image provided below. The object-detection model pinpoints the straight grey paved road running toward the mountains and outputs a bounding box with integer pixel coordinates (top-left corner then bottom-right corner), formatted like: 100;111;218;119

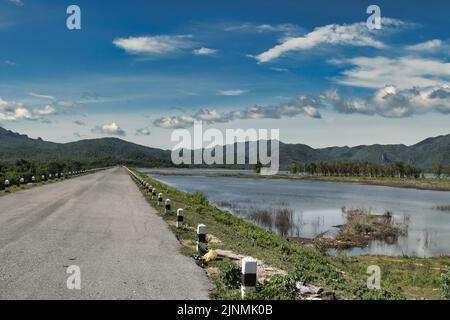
0;168;210;300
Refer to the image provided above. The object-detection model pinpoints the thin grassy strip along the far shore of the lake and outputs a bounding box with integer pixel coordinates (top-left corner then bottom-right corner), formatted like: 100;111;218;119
152;172;450;191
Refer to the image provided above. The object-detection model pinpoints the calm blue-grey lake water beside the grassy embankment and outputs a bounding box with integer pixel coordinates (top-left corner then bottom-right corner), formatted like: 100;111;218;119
151;174;450;257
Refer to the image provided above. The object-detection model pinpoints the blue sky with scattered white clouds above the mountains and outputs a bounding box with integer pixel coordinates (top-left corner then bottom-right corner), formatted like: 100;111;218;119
0;0;450;149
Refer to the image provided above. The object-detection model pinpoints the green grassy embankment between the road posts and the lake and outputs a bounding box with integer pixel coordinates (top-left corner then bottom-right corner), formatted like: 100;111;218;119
128;171;450;299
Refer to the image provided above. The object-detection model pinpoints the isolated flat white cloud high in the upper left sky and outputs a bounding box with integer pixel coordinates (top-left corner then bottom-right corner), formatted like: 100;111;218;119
113;35;195;56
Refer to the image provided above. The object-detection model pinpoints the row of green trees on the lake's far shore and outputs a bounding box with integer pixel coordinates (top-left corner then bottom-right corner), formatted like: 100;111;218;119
290;162;430;179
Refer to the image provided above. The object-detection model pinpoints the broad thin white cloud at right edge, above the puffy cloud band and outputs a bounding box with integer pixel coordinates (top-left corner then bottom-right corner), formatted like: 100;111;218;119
330;56;450;89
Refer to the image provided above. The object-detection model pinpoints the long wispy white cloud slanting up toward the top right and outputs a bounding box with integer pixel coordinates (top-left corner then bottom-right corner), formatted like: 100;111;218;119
254;18;406;63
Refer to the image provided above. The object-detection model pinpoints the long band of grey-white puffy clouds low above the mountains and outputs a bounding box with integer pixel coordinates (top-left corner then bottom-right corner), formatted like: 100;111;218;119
154;83;450;129
